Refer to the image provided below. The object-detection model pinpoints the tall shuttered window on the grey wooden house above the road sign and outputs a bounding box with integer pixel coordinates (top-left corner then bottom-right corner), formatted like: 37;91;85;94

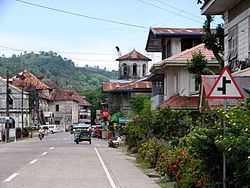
227;25;238;70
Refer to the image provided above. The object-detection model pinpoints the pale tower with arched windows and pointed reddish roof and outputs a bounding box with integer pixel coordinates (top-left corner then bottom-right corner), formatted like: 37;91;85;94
116;49;151;80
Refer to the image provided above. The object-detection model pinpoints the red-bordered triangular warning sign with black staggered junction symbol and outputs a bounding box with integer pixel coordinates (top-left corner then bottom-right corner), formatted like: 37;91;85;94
207;67;244;99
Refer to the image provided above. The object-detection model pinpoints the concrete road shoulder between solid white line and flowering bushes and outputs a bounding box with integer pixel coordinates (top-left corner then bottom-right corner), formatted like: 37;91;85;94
96;140;160;188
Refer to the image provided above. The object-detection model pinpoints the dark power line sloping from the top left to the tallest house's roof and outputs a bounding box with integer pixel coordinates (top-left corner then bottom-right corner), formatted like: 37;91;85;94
16;0;149;29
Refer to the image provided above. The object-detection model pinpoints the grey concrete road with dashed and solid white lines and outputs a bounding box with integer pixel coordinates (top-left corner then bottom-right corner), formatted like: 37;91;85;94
0;133;159;188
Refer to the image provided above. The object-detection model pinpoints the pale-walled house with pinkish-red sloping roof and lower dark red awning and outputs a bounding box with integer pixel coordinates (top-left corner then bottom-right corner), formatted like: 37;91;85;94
150;44;219;110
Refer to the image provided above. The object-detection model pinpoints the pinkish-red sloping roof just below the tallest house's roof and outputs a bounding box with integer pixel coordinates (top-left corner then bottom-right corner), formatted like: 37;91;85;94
163;44;215;62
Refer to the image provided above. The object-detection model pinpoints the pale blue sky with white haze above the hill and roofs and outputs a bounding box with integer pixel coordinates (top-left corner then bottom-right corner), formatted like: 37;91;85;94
0;0;222;70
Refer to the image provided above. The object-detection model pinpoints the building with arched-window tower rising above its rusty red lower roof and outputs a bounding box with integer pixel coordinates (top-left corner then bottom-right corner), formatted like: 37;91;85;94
102;49;152;114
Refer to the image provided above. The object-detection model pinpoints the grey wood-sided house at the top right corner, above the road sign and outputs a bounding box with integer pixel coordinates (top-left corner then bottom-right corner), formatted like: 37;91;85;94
201;0;250;70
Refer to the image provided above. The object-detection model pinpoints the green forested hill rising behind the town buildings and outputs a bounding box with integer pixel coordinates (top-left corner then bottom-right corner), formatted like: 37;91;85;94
0;52;117;91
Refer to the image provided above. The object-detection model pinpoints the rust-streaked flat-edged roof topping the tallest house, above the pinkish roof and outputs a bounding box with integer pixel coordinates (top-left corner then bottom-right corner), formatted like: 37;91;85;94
152;28;204;35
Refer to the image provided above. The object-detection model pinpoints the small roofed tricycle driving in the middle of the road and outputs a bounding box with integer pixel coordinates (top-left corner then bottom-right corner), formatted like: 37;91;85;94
73;124;91;144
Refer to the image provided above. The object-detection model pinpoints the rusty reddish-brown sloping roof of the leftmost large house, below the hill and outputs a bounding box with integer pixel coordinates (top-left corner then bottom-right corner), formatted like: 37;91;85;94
13;70;50;90
